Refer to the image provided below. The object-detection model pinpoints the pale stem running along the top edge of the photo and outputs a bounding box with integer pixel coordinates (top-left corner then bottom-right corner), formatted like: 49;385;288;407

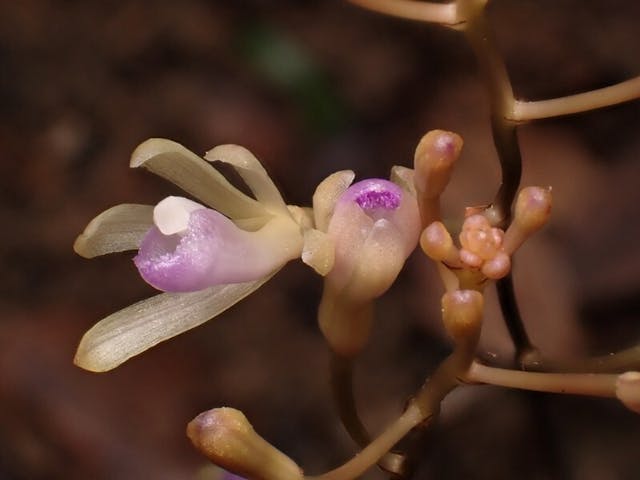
348;0;460;26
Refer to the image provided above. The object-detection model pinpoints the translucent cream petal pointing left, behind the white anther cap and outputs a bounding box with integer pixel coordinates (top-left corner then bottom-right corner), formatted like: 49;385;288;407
73;203;153;258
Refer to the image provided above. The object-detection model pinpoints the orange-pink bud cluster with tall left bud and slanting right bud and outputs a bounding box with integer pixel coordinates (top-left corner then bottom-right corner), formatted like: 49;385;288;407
415;130;551;289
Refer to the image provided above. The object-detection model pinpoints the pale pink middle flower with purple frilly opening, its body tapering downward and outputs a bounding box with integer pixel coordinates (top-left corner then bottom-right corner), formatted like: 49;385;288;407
318;179;420;356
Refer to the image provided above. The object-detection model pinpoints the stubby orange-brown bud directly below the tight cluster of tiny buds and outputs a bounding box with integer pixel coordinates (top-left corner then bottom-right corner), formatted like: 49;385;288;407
442;290;484;343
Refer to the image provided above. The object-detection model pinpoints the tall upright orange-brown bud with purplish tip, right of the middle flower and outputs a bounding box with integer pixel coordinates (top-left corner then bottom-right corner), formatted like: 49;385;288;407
414;130;463;227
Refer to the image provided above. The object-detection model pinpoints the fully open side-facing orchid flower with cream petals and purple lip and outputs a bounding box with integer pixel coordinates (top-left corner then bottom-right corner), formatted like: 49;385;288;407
74;139;318;371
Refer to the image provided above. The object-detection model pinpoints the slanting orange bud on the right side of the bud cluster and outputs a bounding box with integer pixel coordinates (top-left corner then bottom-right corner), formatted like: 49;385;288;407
503;187;551;255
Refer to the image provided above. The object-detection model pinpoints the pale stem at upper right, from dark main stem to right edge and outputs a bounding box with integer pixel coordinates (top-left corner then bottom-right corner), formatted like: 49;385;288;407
505;76;640;122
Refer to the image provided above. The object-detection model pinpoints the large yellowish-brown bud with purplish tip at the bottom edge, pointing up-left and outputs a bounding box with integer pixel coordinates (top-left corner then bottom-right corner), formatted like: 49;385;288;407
187;407;303;480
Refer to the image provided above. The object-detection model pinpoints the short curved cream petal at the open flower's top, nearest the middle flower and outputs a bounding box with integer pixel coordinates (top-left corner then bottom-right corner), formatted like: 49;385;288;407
204;144;289;215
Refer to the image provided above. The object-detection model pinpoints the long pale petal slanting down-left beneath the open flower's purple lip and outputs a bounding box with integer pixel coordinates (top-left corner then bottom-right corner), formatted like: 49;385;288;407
74;275;272;372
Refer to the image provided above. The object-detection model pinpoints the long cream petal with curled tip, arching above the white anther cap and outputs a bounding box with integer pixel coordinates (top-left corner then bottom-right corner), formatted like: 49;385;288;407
130;138;266;219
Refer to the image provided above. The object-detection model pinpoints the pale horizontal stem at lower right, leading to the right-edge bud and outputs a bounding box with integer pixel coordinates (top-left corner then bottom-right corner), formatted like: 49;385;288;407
462;362;618;397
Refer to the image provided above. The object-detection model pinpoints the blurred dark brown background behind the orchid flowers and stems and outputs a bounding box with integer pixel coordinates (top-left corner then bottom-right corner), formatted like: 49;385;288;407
0;0;640;480
